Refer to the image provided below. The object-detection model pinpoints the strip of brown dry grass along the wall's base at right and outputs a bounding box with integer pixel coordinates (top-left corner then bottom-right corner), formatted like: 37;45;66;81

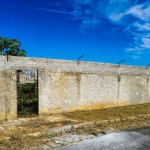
63;103;150;121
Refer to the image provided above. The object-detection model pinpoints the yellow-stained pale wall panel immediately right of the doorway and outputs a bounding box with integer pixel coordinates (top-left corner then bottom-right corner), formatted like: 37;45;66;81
39;70;79;113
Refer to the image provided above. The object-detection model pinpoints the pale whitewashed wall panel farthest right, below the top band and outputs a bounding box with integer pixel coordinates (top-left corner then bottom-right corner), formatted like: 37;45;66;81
118;75;149;104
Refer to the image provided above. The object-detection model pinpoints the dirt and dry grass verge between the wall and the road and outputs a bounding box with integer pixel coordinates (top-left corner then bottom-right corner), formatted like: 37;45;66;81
0;104;150;150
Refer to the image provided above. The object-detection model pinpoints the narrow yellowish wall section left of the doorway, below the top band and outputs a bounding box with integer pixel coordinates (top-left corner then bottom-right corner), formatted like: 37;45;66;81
0;70;17;120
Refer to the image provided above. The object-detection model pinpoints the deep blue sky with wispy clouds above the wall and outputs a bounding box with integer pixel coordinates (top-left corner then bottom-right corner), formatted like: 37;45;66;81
0;0;150;66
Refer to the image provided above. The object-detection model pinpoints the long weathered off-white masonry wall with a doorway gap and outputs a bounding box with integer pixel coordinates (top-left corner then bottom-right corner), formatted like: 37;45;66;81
0;56;150;120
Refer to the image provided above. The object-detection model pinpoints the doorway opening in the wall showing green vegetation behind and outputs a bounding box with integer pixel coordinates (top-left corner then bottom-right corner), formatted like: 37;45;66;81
17;70;38;117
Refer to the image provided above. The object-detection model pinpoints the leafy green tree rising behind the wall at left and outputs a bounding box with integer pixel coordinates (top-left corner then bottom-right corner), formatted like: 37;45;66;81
0;37;26;56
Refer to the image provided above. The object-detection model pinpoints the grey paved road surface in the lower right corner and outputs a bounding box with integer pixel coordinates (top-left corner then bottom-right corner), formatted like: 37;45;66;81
55;128;150;150
